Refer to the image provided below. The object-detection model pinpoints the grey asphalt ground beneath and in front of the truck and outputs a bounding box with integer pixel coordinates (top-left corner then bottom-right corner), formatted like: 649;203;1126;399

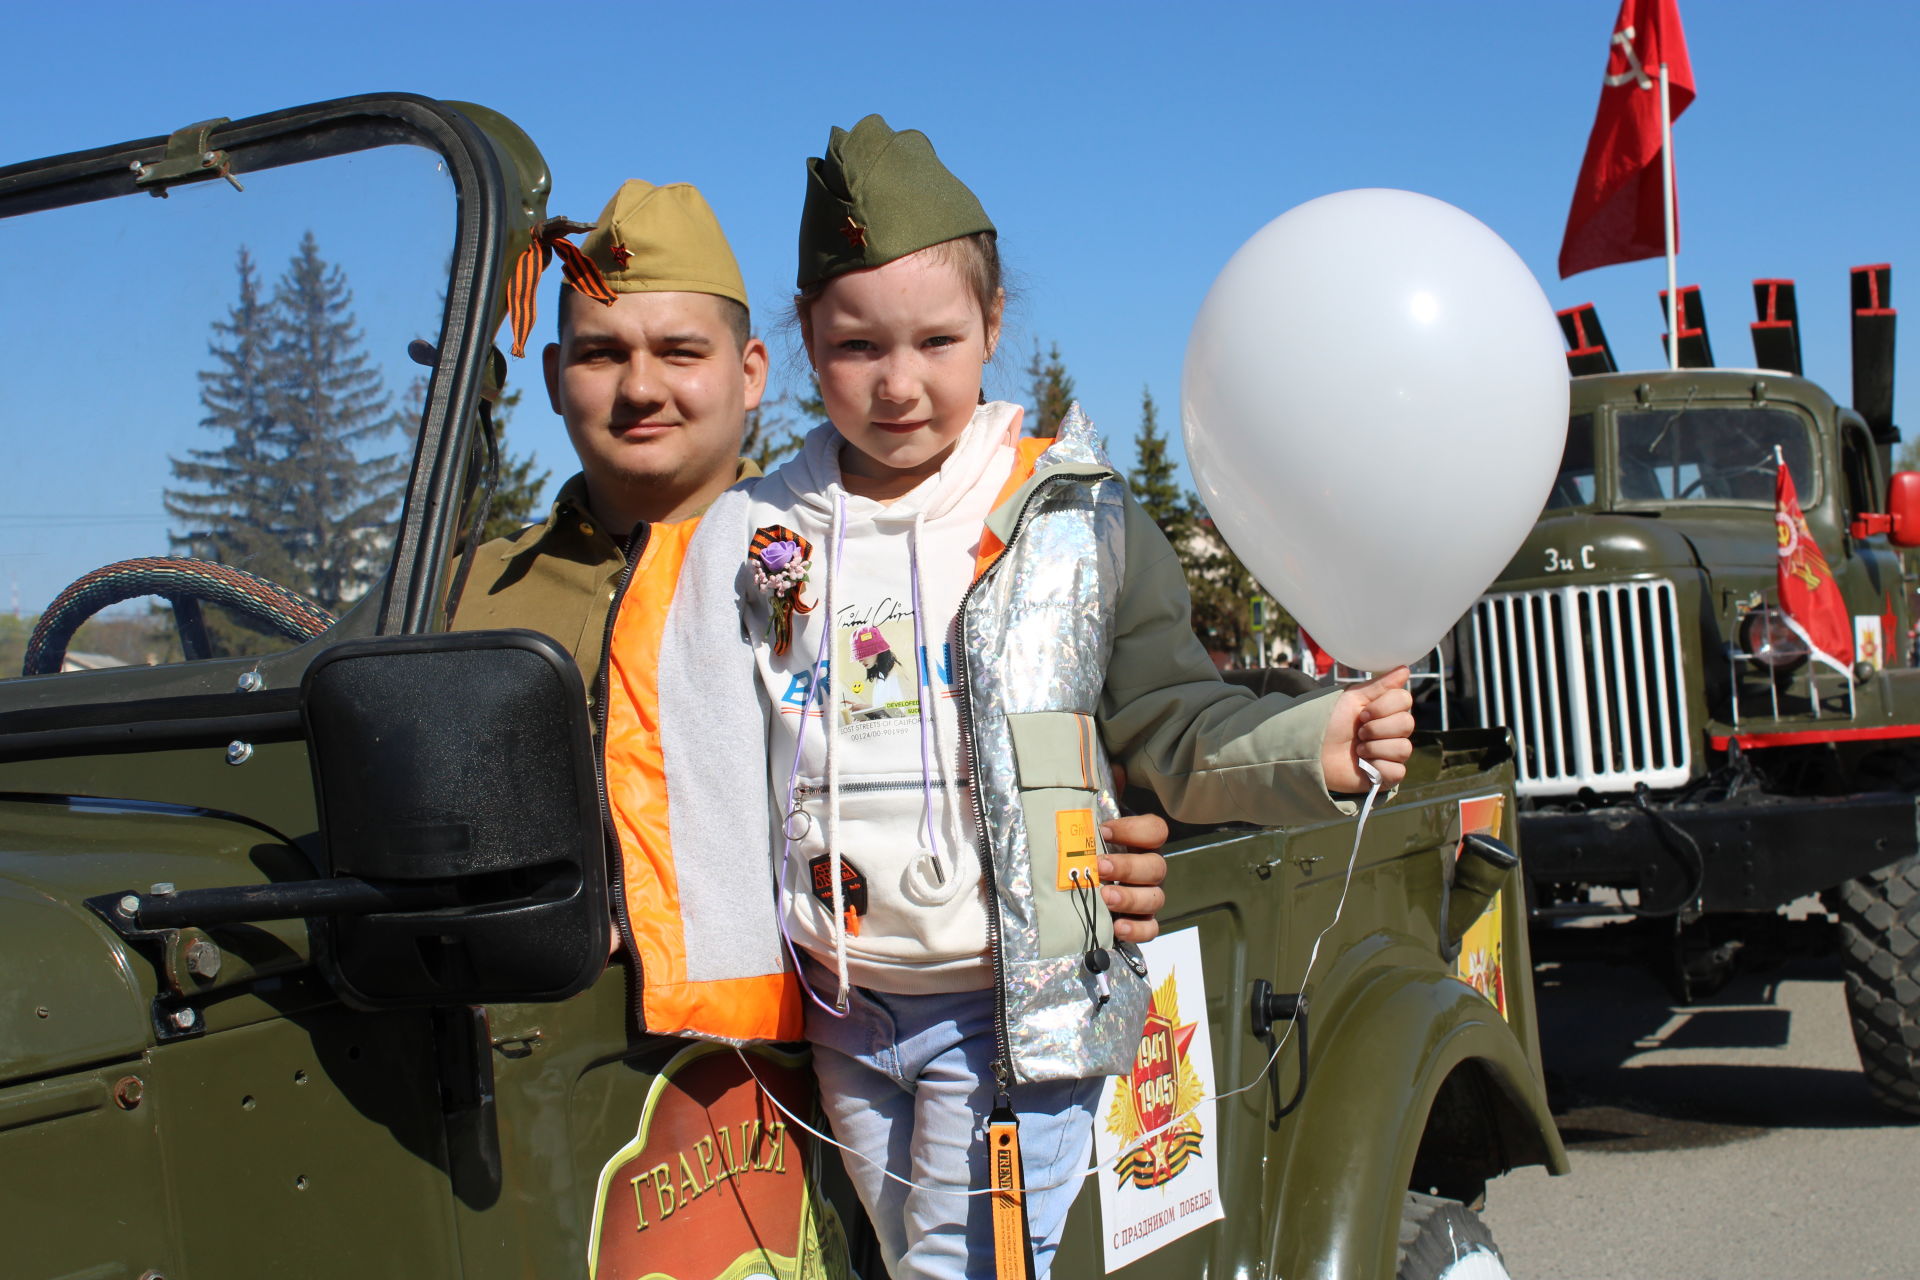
1484;932;1920;1280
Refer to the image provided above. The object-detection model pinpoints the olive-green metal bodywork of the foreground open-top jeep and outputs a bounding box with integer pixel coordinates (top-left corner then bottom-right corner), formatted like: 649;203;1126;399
0;100;1565;1280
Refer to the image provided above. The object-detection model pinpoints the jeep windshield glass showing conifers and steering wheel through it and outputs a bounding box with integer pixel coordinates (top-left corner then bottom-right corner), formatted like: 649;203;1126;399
0;146;455;677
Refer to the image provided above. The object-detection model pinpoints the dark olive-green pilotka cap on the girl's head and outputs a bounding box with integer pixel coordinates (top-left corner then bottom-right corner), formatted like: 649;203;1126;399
797;115;993;290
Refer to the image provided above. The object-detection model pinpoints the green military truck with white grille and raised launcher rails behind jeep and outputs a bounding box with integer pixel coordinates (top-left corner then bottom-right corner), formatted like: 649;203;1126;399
1453;278;1920;1115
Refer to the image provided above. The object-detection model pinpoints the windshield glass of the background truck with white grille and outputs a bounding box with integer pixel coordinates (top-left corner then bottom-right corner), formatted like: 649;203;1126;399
1615;407;1820;507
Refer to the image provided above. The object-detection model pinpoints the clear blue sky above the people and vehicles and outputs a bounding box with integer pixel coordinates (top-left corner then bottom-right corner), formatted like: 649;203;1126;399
0;0;1920;594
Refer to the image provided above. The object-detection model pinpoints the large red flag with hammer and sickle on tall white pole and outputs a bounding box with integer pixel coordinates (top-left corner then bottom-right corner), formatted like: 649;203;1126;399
1561;0;1693;278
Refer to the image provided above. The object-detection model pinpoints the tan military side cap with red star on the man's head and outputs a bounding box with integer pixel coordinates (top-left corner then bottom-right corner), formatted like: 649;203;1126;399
580;178;747;307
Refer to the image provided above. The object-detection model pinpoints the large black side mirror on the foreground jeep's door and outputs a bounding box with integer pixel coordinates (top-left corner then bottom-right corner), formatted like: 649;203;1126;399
301;631;609;1009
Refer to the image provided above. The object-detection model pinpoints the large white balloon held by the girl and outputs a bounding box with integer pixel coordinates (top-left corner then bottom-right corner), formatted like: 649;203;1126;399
1181;190;1567;672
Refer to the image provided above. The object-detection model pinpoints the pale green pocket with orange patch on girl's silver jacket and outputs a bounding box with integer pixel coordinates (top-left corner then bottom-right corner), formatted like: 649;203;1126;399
1006;712;1114;960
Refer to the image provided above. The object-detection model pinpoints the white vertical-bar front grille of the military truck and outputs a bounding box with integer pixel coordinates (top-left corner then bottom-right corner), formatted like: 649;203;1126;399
1473;581;1692;796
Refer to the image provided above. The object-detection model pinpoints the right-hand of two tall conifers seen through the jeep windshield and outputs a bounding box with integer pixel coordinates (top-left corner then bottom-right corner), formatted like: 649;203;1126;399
271;230;407;610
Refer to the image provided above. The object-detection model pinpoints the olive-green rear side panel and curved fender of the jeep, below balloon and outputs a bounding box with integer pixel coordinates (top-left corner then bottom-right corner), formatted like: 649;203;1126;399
1054;735;1567;1280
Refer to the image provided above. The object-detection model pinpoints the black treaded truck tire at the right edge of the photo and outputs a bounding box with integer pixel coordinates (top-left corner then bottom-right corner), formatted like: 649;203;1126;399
1832;858;1920;1117
